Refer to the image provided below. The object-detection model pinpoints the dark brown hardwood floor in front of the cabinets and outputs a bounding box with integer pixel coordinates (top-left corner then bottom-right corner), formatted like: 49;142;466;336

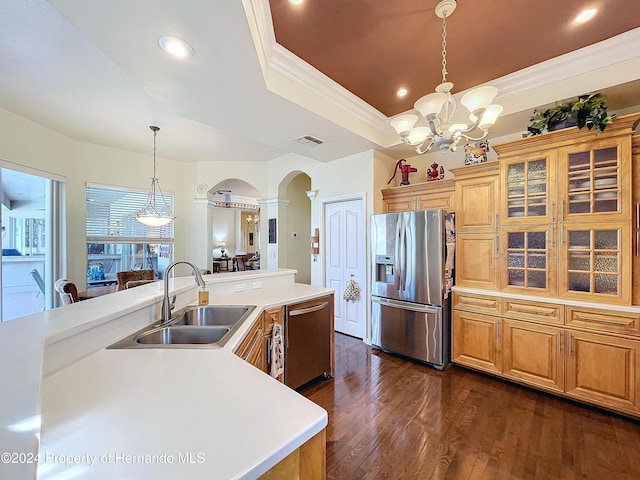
301;334;640;480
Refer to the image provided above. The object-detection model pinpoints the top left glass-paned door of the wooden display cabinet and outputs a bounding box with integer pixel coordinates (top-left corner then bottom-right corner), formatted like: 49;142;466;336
500;151;556;224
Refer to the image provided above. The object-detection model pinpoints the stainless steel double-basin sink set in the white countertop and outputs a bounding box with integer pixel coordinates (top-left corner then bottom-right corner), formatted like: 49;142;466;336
107;305;256;349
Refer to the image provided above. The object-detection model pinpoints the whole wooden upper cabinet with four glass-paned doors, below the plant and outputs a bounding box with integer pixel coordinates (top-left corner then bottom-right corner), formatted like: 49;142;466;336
494;114;640;304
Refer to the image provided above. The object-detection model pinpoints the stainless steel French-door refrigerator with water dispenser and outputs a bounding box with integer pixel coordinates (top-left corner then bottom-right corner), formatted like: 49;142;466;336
371;210;455;369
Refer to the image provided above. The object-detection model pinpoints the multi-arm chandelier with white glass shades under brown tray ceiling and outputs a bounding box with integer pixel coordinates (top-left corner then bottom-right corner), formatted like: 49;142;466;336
389;0;502;155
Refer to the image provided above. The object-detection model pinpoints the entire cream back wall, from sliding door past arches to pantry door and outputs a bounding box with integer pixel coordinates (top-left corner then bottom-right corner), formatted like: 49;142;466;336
0;110;394;287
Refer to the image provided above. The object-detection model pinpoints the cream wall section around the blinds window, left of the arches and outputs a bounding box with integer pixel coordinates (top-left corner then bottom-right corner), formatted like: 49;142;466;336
0;109;192;289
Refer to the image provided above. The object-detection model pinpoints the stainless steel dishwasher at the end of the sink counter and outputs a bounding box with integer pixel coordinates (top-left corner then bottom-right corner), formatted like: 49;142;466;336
284;296;333;388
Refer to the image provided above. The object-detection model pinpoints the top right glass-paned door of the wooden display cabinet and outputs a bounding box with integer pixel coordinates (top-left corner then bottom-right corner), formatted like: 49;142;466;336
558;137;631;222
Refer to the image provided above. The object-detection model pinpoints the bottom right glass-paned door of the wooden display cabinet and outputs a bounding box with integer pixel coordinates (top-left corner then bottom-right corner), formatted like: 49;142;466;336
558;222;631;304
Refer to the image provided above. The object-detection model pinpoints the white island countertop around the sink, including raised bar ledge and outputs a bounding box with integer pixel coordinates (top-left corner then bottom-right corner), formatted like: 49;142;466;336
0;275;333;479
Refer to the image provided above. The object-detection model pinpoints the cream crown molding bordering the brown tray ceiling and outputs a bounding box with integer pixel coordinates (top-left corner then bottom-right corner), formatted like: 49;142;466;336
242;0;640;147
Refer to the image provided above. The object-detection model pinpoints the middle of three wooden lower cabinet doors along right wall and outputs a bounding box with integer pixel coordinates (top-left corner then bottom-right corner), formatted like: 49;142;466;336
502;319;564;391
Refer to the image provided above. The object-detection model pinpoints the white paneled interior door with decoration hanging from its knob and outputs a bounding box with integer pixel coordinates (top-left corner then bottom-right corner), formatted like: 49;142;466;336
324;199;367;338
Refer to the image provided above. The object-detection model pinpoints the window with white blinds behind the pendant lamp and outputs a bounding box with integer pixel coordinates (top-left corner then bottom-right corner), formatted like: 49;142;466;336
87;185;173;285
